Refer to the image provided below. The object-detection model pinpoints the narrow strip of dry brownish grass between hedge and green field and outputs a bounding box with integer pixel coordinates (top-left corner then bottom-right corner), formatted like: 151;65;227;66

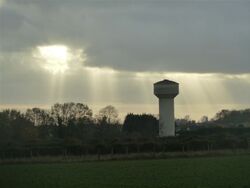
0;149;250;165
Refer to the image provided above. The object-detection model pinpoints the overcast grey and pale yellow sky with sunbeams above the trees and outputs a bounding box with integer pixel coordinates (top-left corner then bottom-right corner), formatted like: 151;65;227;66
0;0;250;120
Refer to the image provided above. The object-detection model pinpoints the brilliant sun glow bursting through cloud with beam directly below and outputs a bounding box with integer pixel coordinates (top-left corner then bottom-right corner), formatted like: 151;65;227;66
32;45;87;102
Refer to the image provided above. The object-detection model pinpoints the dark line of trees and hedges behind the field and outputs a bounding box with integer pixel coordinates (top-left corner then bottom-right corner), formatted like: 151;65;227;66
0;103;250;158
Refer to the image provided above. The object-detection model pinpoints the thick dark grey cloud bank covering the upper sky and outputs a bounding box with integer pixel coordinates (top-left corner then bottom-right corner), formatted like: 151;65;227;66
0;0;250;74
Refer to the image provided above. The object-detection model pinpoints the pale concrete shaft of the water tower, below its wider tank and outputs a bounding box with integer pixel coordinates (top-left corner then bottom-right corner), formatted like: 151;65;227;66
159;98;175;137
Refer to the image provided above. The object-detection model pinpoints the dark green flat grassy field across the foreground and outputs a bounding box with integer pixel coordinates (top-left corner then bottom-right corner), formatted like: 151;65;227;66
0;156;250;188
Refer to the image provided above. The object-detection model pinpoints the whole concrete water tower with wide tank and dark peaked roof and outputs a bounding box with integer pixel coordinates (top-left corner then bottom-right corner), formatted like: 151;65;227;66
154;80;179;137
